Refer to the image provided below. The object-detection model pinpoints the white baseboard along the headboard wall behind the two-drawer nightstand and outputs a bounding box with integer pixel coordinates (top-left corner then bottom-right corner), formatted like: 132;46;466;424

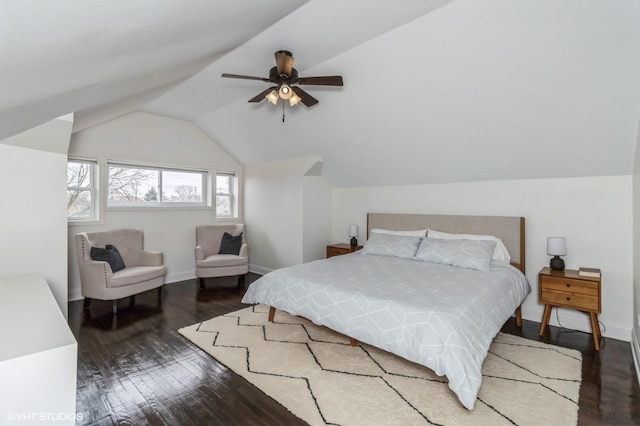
522;306;632;342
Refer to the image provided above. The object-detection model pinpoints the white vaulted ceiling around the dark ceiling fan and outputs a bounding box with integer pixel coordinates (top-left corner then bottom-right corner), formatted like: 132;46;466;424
0;0;640;186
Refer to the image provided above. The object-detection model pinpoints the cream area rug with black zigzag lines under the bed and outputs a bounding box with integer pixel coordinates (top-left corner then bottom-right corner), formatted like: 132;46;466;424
179;305;582;426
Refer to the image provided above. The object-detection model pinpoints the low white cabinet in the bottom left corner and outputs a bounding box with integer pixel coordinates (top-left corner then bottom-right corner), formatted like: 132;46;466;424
0;274;77;425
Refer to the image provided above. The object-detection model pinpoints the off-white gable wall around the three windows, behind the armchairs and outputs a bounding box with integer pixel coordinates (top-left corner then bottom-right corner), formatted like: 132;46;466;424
65;112;243;300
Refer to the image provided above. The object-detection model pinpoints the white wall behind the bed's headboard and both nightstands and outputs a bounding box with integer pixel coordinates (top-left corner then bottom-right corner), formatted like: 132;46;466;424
332;176;633;341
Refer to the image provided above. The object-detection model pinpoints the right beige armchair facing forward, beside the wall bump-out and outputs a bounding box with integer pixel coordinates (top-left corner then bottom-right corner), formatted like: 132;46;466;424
195;224;249;290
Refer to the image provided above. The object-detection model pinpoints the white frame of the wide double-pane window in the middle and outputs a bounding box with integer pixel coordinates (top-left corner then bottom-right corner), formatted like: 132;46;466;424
104;160;209;209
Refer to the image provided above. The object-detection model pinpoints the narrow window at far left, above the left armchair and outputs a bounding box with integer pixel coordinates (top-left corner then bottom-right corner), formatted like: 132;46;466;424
67;159;98;221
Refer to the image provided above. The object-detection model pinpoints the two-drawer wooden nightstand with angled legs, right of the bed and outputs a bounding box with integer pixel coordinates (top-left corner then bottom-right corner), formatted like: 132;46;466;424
538;268;602;350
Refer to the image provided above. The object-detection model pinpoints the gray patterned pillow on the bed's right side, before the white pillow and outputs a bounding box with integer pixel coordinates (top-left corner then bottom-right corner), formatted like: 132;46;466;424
415;238;496;271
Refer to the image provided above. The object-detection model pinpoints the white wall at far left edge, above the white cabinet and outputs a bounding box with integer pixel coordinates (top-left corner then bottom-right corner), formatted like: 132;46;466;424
0;117;73;318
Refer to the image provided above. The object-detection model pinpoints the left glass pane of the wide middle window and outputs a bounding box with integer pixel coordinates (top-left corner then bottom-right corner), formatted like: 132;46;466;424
108;166;159;203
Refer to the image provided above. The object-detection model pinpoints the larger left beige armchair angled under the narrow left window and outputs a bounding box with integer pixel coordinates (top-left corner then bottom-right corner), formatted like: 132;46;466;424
75;229;167;314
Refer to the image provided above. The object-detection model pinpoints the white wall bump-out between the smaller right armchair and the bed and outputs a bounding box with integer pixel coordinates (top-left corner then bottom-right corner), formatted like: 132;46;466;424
245;157;330;273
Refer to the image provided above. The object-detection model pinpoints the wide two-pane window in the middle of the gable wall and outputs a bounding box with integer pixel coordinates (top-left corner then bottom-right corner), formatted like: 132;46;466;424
107;163;207;207
